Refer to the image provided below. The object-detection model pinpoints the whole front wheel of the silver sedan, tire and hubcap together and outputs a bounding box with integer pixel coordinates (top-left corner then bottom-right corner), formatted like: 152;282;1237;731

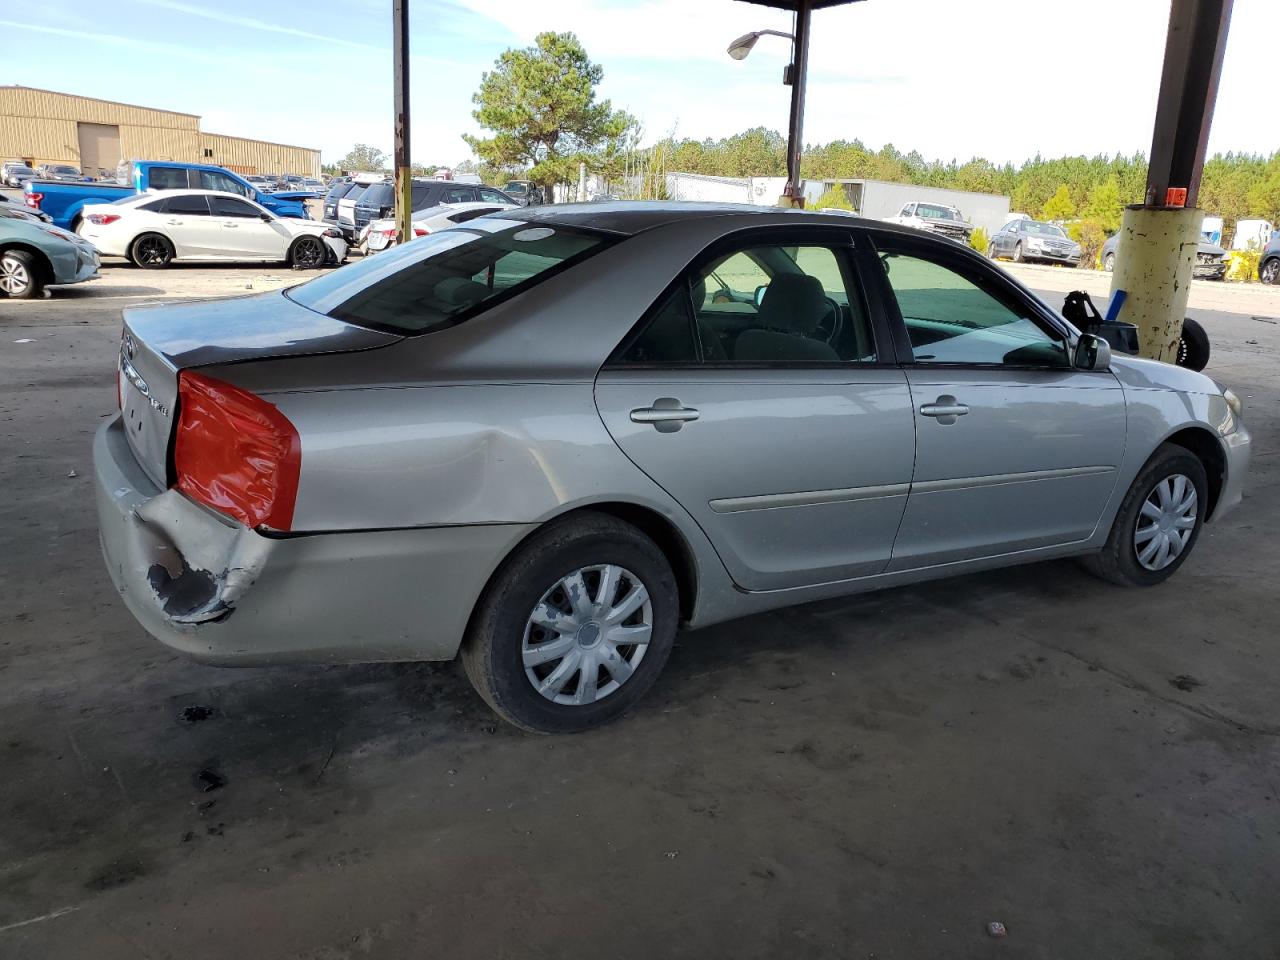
1084;443;1208;586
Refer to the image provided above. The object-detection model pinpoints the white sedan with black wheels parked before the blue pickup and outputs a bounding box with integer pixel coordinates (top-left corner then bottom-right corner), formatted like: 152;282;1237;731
79;189;347;270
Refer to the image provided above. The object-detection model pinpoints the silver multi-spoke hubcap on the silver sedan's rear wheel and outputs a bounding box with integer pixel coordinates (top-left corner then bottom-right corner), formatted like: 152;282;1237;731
520;563;653;707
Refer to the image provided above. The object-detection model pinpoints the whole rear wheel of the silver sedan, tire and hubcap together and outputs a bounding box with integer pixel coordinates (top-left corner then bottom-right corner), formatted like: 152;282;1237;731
462;513;680;733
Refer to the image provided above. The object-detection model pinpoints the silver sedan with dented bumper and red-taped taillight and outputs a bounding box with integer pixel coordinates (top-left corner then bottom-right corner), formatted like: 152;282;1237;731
93;204;1249;731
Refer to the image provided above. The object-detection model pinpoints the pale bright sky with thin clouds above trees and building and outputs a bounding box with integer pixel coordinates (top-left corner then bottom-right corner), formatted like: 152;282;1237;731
0;0;1280;164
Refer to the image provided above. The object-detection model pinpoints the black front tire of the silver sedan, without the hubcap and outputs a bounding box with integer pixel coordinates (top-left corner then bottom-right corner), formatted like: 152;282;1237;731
1082;443;1208;586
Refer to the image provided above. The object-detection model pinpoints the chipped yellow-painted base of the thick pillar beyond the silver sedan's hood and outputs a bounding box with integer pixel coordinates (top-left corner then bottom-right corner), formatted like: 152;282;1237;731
1111;206;1204;364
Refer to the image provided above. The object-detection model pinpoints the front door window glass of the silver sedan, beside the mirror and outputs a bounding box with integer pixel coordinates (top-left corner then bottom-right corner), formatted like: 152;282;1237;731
881;252;1068;366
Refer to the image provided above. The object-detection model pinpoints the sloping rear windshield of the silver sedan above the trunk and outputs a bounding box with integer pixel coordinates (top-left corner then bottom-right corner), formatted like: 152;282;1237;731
285;218;614;334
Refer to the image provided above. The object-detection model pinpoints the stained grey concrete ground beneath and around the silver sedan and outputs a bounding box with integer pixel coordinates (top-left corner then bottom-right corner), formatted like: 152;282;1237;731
0;268;1280;960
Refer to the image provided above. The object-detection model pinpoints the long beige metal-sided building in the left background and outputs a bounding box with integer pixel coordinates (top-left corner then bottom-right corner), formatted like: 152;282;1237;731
0;87;320;177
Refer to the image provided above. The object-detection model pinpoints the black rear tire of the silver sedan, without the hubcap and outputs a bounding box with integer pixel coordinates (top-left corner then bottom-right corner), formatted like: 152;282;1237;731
462;513;680;733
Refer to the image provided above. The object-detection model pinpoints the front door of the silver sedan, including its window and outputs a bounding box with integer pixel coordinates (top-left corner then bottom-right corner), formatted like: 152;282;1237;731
865;238;1126;571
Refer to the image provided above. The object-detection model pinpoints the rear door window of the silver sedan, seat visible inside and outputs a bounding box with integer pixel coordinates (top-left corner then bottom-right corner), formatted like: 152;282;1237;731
617;244;877;366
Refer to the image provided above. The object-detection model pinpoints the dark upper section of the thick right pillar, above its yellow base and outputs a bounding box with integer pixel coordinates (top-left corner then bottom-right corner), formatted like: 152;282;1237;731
1146;0;1233;207
